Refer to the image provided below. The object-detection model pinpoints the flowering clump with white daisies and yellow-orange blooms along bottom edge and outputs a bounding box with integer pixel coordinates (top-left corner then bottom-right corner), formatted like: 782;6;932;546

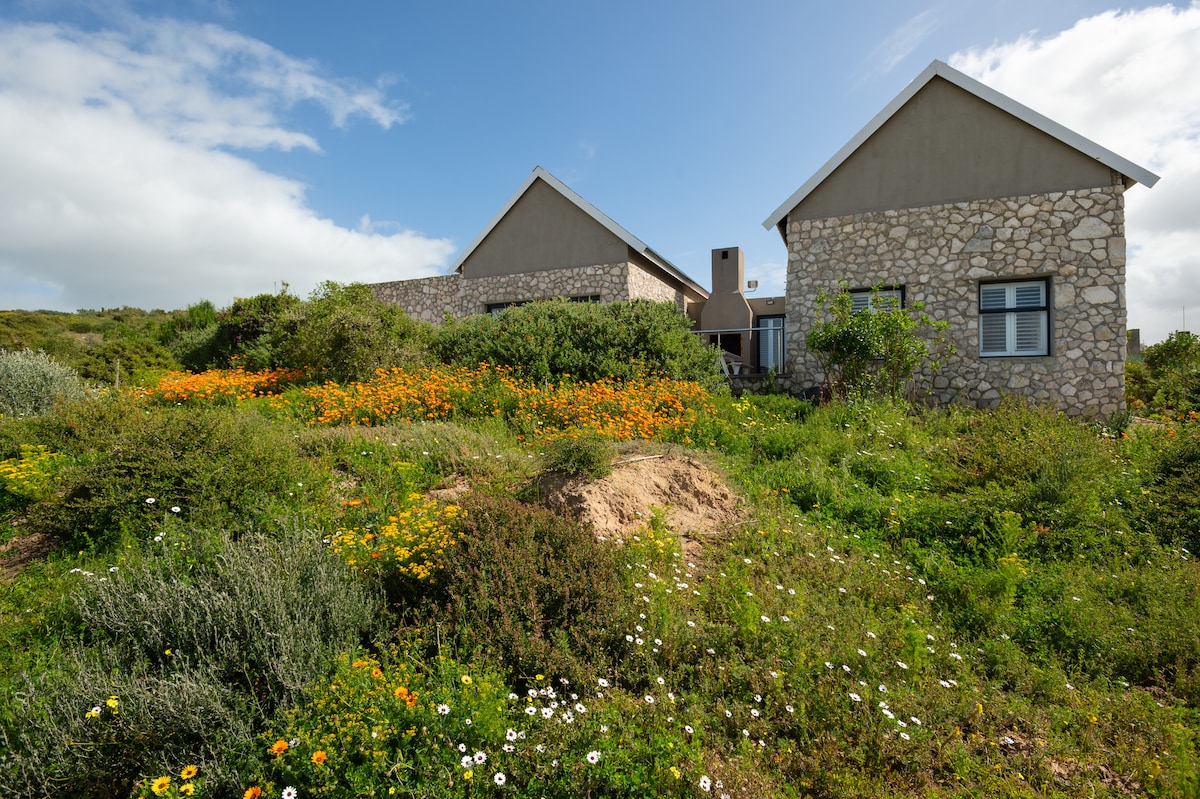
260;641;700;797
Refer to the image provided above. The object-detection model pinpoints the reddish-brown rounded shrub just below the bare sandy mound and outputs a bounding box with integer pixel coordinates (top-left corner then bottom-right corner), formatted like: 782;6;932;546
408;494;630;681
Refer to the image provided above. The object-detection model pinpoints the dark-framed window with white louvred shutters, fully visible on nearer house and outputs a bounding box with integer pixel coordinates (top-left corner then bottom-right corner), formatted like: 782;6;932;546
979;280;1050;358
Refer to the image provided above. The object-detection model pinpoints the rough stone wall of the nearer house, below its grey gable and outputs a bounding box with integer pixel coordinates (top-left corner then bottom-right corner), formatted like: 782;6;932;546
786;178;1126;417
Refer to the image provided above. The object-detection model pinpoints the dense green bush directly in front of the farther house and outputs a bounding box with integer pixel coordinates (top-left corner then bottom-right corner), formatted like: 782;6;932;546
431;300;720;386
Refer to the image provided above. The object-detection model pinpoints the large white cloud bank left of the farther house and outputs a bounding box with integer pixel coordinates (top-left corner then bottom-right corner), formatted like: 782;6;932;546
0;18;454;310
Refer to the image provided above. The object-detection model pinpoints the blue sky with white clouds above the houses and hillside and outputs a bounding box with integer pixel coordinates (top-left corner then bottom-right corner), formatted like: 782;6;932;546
0;0;1200;342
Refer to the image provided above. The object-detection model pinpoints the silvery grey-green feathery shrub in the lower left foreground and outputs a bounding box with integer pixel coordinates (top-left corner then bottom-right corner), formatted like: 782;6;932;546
0;528;382;799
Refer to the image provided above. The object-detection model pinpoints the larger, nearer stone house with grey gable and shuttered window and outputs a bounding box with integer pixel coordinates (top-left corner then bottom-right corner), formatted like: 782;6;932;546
763;61;1158;417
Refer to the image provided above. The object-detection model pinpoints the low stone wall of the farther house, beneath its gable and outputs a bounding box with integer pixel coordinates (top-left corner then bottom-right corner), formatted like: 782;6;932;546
371;263;684;324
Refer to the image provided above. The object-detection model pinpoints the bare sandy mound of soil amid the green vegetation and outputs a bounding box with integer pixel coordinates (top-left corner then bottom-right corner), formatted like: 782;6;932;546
538;453;743;557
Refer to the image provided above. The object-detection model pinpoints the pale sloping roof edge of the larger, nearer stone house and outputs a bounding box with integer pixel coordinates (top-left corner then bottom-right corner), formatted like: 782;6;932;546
762;61;1158;230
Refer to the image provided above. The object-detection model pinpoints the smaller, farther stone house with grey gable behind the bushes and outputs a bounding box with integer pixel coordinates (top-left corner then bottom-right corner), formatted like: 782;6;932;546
372;167;708;323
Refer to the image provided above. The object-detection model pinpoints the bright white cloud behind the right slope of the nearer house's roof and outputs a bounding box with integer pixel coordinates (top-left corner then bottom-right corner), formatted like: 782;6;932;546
950;2;1200;343
